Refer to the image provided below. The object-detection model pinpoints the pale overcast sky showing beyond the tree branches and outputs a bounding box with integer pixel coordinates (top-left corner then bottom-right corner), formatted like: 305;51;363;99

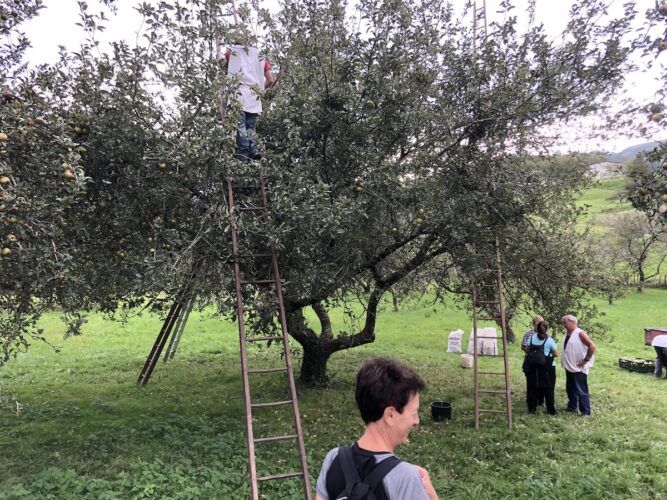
18;0;667;152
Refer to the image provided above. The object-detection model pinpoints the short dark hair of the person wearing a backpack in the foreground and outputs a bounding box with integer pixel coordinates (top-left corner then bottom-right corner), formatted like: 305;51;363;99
355;358;426;424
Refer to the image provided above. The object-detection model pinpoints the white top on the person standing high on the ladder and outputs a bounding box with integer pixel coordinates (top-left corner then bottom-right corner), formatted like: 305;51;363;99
227;45;266;113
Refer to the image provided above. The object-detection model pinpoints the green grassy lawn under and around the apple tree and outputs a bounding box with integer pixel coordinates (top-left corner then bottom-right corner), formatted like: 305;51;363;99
0;289;667;499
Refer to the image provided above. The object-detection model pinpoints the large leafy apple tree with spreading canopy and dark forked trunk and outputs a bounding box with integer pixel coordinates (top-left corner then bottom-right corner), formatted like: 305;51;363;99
0;0;634;381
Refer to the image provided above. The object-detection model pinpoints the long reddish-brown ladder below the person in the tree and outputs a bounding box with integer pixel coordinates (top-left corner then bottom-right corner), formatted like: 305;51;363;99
227;175;312;500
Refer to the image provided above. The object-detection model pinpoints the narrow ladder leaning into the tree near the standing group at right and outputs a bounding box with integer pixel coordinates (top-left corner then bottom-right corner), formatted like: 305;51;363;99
471;235;512;430
